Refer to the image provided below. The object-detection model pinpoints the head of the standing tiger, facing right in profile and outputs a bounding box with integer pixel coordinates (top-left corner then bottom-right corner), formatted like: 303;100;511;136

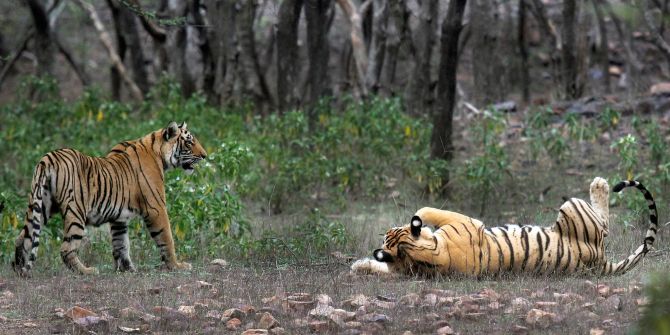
161;122;207;174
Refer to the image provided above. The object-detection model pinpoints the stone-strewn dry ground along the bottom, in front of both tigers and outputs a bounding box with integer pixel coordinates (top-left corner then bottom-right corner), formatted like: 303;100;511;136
0;255;654;334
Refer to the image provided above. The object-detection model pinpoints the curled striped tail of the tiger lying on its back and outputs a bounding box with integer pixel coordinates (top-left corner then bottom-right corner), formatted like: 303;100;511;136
602;180;658;275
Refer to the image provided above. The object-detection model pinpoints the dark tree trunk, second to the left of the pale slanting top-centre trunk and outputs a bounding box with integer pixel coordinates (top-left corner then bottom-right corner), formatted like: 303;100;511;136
275;0;302;113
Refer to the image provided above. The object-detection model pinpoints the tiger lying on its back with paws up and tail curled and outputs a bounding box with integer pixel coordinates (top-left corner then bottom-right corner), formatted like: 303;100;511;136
351;178;658;275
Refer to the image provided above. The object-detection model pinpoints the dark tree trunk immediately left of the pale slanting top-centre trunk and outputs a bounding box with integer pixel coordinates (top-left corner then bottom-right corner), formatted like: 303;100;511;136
305;0;333;115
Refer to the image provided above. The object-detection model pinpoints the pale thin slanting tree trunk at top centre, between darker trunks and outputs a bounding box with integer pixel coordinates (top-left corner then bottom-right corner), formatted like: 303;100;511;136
336;0;368;97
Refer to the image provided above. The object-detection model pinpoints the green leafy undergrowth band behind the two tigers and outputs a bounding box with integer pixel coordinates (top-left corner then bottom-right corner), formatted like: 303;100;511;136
0;78;670;270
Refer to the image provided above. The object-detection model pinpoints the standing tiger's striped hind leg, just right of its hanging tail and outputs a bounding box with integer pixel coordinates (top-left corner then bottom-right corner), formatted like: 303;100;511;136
60;213;98;275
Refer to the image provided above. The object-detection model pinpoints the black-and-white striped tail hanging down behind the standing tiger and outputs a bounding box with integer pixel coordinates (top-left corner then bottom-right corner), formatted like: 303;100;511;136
12;160;50;276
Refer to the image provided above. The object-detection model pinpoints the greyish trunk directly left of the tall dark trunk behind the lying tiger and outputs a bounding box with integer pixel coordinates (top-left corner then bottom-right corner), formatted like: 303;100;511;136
407;0;439;115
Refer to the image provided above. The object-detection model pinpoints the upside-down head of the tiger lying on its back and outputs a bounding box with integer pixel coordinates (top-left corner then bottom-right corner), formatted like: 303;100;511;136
373;215;437;270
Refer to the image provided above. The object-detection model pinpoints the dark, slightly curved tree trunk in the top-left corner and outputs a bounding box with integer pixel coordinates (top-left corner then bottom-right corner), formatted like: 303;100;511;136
27;0;54;76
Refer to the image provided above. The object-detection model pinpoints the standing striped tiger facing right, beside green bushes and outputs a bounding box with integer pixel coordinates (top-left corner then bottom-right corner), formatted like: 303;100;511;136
12;122;207;276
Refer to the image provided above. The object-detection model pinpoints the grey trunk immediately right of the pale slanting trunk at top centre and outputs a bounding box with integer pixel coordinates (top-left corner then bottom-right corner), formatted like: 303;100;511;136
365;0;388;93
